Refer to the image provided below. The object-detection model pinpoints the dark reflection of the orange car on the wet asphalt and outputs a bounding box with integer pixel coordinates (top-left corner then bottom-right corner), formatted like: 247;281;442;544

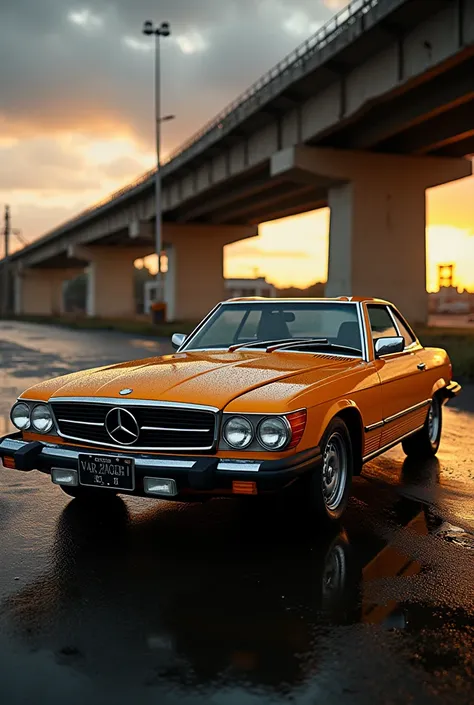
1;460;444;690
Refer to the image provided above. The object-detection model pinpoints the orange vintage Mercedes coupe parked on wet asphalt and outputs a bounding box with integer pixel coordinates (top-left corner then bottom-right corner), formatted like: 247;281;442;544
0;297;460;521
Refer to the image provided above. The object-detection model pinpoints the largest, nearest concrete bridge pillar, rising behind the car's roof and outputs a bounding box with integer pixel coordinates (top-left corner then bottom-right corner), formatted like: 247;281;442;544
272;147;472;323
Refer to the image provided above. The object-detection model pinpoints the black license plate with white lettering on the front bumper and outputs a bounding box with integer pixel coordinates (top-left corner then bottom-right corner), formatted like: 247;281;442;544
78;453;135;492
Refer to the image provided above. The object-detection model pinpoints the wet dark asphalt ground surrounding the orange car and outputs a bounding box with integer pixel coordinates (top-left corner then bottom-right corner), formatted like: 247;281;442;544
0;322;474;705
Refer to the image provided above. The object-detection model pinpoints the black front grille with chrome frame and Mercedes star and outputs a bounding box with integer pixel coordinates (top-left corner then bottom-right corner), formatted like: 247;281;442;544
50;400;217;451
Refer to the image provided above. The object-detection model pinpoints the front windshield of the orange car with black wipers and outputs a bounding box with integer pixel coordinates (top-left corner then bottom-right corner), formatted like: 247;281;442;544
184;301;362;355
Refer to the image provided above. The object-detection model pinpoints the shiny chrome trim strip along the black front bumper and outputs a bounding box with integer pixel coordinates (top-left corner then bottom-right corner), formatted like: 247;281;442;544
0;438;261;472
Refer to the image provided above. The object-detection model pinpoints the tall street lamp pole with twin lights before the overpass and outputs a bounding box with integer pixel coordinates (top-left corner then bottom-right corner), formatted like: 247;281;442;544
143;21;174;310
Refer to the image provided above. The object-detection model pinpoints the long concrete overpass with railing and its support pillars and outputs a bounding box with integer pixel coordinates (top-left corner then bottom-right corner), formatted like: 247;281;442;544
1;0;474;321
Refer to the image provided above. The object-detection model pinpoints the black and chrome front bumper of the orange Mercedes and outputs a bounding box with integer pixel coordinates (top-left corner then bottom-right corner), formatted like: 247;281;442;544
0;433;321;501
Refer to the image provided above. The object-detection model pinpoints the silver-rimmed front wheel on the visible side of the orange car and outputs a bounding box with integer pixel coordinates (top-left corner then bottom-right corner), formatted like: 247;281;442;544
306;418;354;525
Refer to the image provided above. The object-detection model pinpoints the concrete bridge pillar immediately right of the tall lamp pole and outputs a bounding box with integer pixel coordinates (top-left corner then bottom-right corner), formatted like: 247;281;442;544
164;224;258;321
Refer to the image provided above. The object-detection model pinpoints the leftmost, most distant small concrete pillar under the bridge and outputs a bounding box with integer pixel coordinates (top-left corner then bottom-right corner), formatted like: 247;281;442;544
13;268;84;316
